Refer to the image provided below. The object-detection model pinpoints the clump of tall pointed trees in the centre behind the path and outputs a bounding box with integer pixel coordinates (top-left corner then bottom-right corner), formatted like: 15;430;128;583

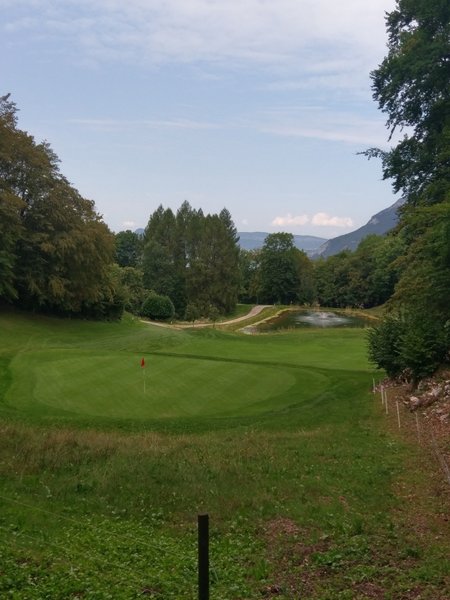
143;202;243;316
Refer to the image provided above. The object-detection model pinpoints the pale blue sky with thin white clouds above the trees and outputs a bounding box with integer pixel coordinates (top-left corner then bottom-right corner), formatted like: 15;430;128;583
0;0;397;239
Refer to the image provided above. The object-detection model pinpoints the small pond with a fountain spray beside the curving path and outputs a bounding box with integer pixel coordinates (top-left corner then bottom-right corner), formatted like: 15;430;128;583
243;310;372;333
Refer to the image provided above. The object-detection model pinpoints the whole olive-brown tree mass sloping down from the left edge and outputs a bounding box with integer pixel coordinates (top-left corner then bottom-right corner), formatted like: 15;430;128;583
0;95;121;317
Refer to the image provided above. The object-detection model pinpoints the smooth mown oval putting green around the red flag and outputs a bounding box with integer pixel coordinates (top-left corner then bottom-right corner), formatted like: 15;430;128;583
5;349;329;419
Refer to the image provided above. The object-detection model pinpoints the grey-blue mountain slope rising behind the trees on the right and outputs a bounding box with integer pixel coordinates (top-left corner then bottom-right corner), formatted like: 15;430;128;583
311;199;403;258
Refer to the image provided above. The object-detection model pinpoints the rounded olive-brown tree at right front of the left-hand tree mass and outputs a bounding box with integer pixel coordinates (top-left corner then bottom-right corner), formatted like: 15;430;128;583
16;181;114;314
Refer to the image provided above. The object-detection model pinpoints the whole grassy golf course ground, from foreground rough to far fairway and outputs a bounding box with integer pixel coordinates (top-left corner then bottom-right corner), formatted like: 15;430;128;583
0;306;450;600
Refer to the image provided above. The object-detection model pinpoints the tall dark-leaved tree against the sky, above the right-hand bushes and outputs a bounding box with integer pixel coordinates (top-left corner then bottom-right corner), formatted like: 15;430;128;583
366;0;450;205
